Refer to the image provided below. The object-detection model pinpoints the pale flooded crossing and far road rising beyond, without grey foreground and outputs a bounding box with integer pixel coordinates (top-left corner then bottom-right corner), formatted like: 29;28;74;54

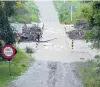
33;1;91;62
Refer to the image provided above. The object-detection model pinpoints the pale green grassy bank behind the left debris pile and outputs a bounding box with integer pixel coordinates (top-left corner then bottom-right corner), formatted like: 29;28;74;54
9;1;40;23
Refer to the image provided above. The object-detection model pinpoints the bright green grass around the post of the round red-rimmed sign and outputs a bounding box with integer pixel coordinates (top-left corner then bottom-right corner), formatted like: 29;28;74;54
0;50;32;87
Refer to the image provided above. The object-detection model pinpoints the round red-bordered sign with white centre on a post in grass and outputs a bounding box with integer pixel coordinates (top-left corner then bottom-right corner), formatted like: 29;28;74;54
1;44;16;60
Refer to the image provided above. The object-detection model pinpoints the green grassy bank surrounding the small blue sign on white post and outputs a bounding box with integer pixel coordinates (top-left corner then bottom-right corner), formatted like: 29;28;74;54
54;0;89;24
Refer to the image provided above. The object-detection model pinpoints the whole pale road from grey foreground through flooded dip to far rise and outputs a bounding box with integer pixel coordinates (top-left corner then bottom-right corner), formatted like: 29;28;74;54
7;1;94;87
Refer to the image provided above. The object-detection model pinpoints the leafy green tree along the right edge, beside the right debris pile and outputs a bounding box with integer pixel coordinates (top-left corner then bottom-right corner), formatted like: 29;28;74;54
82;1;100;49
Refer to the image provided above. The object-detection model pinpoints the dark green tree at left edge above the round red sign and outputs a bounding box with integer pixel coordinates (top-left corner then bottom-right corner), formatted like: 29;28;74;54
0;1;15;44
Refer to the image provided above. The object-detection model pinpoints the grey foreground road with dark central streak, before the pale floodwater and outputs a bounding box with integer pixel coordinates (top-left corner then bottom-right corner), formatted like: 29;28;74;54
7;61;83;87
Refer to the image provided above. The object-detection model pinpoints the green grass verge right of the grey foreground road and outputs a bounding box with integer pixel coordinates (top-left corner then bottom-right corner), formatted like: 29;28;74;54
78;60;100;87
